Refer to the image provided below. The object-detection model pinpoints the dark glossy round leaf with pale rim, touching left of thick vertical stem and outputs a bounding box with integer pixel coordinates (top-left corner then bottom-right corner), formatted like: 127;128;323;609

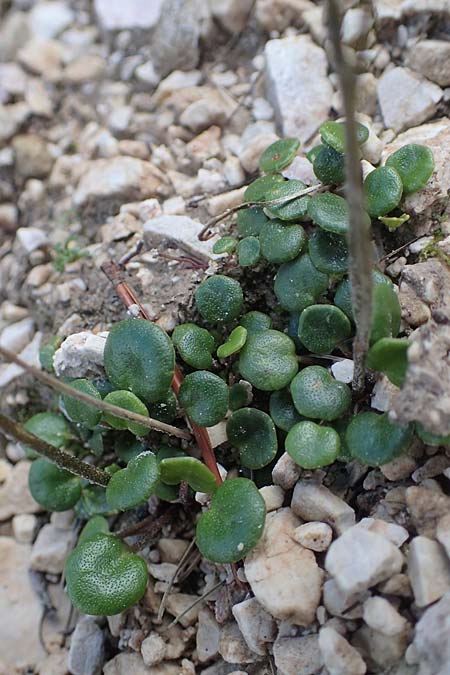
298;305;352;354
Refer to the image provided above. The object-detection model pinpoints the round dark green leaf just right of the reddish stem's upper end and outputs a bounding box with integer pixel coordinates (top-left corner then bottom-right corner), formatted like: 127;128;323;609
195;274;244;323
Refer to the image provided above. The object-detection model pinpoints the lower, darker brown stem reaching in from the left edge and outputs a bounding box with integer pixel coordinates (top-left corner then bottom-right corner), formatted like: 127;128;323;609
0;413;111;487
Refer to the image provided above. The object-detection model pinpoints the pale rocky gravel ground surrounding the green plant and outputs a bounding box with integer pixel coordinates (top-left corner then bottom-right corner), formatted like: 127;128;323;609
0;0;450;675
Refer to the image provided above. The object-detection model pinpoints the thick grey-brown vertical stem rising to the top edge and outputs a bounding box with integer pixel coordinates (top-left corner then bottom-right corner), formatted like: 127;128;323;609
328;0;373;393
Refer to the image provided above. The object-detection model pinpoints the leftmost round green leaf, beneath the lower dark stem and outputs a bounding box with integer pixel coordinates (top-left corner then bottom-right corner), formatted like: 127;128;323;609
28;457;81;511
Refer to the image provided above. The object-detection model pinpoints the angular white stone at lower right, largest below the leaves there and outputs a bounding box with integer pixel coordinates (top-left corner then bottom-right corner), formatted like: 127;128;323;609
325;527;403;594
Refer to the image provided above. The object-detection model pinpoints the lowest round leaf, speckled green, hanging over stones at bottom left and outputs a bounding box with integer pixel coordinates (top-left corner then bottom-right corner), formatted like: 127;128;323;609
65;534;148;616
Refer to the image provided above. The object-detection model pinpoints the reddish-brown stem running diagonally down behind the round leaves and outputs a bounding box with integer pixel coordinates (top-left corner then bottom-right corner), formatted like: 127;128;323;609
102;262;222;485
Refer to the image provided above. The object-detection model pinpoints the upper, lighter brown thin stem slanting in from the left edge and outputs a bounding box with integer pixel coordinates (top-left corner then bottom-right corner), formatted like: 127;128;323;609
0;347;191;439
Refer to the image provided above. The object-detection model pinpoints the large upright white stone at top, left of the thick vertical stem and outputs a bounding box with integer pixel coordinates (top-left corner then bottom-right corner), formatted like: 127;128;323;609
264;35;333;142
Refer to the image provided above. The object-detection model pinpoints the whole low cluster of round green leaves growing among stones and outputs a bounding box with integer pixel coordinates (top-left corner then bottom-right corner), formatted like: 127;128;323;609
19;122;438;614
